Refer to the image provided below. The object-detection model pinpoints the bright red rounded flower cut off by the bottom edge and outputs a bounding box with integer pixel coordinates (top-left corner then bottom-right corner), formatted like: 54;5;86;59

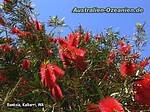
96;97;124;112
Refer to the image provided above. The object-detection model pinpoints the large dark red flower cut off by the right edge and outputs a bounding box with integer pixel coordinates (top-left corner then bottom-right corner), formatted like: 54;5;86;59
134;74;150;106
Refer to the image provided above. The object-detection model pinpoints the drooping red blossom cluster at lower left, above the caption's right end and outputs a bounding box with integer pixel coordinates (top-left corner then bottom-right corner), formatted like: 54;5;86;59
40;63;64;100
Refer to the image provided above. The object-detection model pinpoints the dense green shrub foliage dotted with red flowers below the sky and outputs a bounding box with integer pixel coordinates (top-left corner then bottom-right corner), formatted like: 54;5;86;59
0;0;150;112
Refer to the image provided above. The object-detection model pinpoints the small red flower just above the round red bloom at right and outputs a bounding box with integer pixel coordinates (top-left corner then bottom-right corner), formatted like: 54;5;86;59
120;41;131;56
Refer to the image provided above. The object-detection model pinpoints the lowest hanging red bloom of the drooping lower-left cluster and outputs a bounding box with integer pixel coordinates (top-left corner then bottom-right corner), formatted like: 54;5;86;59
52;84;63;100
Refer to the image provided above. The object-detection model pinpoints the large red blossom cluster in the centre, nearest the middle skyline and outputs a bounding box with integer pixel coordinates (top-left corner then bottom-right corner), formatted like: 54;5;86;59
58;33;90;70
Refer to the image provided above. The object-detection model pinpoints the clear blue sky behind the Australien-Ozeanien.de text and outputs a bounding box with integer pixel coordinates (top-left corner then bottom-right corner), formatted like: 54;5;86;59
33;0;150;56
